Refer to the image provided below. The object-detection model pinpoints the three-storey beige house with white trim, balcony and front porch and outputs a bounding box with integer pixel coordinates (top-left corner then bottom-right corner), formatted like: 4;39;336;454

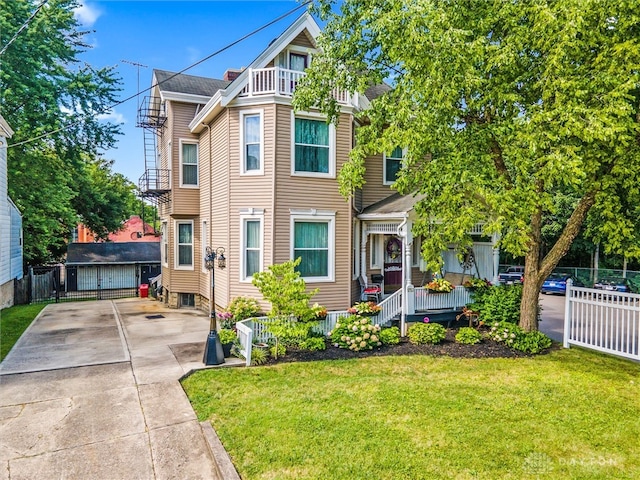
138;14;497;310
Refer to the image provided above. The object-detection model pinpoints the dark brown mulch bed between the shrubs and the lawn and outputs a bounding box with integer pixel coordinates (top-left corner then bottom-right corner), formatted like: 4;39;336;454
267;328;559;364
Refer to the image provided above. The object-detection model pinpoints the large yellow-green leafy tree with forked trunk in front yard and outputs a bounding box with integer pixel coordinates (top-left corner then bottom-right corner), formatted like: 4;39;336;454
295;0;640;330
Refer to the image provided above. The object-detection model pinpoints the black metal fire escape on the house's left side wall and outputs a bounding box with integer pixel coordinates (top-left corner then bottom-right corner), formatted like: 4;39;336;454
136;97;171;205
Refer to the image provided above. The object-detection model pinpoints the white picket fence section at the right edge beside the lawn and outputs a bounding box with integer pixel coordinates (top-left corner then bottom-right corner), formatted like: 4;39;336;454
563;281;640;360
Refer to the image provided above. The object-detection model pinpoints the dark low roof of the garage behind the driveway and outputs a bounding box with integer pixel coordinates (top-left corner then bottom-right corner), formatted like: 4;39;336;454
67;242;160;265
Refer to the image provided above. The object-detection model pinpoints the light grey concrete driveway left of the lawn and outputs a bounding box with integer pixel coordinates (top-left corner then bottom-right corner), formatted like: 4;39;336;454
0;299;240;480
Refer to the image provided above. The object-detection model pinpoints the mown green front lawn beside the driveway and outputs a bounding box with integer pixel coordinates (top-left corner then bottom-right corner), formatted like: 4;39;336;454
183;348;640;480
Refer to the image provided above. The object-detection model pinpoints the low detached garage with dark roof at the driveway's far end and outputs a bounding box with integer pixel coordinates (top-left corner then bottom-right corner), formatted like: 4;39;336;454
65;242;160;292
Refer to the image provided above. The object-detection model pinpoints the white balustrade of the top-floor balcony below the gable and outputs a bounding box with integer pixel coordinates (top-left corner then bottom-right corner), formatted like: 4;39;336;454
240;67;350;105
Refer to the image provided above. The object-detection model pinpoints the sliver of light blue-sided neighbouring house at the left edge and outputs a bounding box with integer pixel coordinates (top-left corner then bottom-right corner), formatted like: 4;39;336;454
0;115;23;309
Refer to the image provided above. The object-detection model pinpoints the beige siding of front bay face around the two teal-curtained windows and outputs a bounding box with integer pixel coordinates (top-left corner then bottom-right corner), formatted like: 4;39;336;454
274;105;352;309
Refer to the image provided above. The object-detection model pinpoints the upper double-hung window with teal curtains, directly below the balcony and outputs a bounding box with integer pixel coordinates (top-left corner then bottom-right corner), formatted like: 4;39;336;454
292;116;335;177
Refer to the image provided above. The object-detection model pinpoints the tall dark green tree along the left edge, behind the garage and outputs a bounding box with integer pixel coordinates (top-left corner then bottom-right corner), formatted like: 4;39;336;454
0;0;132;264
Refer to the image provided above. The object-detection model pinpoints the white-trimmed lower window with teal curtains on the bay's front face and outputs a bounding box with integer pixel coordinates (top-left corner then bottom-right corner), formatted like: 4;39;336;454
291;212;335;281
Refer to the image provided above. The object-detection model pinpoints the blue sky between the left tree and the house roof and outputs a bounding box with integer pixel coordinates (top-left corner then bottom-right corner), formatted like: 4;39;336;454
76;0;314;184
